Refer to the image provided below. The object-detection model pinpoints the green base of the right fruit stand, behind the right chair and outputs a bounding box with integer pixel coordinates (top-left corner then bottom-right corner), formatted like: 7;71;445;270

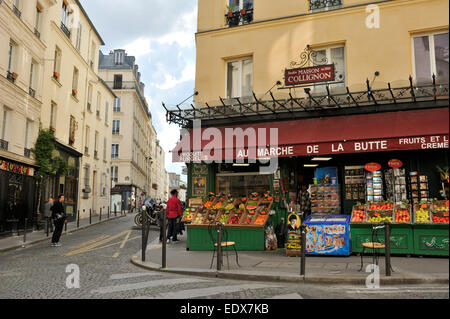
350;223;414;255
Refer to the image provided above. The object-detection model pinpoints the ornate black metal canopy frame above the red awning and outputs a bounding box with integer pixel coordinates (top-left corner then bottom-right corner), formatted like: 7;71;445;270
162;75;449;128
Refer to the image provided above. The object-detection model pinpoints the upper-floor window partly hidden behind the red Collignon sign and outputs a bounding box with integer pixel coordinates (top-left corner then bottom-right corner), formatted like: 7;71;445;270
313;46;346;94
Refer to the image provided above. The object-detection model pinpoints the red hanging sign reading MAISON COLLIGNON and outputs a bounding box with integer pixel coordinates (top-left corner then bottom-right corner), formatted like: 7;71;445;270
284;64;334;85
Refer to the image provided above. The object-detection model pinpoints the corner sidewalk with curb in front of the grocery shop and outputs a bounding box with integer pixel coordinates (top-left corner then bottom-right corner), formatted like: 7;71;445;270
131;233;449;285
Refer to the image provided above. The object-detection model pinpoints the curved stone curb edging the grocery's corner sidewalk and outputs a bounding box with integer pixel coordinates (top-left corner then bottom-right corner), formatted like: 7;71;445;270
130;256;449;285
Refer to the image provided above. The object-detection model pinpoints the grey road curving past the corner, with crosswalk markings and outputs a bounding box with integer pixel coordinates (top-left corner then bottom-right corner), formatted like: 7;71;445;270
0;214;449;300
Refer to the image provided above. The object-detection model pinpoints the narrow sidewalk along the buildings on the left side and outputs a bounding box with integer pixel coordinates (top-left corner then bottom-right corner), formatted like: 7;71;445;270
0;213;126;254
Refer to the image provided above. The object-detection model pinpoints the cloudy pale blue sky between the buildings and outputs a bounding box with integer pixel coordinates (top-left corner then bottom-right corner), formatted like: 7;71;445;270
80;0;197;180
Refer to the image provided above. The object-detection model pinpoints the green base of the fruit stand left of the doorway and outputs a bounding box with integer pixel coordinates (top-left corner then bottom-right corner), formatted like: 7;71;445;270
186;225;265;251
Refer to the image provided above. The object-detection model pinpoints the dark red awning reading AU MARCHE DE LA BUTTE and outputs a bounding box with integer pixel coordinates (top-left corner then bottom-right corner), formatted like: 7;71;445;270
172;107;449;162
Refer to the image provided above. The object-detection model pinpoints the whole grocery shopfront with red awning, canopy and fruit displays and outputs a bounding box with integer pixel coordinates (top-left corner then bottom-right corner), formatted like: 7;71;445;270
166;79;449;256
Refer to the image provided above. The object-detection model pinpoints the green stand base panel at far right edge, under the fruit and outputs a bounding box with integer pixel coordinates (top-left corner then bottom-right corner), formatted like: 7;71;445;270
413;224;449;257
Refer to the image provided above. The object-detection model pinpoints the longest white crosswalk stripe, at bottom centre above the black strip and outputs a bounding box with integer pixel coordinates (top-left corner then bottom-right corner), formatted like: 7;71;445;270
135;284;282;299
